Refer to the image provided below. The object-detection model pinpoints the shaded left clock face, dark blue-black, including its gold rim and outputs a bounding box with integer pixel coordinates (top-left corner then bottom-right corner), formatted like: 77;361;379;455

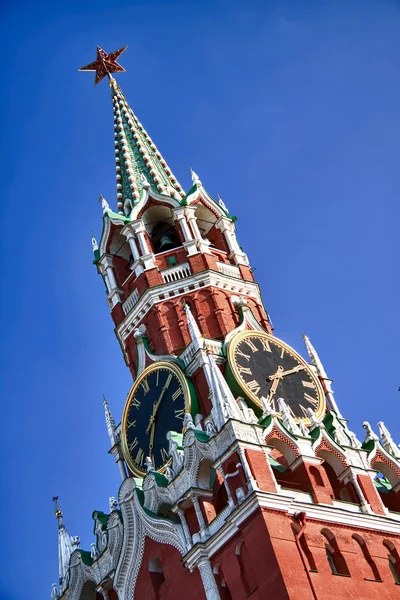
122;362;190;477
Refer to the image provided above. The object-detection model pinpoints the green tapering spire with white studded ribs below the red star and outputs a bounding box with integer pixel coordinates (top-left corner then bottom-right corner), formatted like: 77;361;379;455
110;76;185;214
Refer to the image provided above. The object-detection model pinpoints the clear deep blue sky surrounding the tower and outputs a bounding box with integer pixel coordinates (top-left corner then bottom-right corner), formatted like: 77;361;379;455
0;0;400;600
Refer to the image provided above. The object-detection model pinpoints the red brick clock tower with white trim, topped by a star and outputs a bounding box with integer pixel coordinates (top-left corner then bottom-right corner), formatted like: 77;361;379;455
52;48;400;600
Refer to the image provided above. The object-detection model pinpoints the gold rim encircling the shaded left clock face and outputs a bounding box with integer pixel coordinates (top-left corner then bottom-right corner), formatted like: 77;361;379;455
121;360;191;478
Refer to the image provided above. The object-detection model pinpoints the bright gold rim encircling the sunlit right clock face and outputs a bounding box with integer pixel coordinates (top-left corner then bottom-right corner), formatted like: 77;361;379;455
227;329;326;425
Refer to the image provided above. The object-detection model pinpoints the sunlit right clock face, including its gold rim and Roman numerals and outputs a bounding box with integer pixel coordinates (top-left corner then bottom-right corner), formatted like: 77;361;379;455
228;331;325;420
